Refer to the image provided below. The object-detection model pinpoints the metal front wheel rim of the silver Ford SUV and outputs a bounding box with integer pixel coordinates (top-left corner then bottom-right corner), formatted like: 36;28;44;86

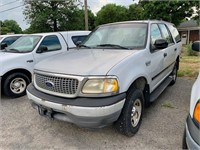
131;99;142;127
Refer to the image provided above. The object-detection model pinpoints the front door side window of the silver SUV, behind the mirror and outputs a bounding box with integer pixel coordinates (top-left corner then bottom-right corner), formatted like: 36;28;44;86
151;24;162;50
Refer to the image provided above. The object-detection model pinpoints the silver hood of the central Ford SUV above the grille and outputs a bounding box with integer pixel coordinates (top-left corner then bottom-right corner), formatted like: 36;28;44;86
35;49;136;75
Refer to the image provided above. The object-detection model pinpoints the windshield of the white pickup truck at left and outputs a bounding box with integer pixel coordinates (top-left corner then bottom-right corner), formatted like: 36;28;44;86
6;35;41;53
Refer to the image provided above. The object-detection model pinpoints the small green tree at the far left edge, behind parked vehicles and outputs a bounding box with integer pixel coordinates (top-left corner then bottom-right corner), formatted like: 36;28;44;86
0;20;22;34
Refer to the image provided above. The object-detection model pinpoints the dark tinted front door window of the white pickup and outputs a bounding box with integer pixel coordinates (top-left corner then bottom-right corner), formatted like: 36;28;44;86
40;35;61;51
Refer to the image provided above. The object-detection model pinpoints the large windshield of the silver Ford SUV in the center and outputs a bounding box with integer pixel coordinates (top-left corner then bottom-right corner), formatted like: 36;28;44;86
82;23;147;49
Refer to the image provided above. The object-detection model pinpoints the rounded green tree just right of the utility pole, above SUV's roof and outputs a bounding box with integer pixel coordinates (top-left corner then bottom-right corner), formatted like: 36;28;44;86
96;4;128;25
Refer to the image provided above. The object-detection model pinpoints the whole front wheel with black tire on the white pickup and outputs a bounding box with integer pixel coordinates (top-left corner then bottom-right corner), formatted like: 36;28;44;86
3;73;30;98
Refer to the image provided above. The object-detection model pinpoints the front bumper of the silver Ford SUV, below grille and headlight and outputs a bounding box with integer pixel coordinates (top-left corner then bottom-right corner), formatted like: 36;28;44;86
27;85;125;128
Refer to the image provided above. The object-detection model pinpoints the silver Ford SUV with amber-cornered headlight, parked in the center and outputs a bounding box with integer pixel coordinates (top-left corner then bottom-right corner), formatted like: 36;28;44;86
27;20;182;136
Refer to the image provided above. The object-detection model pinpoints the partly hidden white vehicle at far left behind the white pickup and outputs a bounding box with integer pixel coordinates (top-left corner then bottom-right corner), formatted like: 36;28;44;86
0;34;23;50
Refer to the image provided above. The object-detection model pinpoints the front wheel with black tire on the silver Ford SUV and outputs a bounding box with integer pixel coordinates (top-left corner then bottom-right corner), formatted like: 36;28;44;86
115;89;144;137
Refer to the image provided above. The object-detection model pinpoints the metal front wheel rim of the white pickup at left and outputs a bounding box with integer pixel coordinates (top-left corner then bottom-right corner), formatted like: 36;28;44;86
10;78;26;94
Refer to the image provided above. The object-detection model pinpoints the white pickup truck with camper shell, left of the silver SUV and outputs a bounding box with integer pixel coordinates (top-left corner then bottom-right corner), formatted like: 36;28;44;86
0;31;90;97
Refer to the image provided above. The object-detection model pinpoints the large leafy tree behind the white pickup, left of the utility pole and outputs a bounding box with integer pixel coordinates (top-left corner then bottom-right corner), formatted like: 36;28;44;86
24;0;94;33
